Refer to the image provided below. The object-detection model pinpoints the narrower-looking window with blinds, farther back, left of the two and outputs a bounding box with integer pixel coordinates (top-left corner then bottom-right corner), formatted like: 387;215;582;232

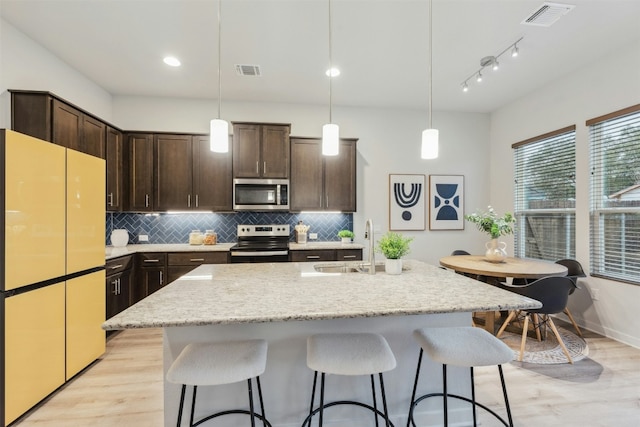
512;126;576;261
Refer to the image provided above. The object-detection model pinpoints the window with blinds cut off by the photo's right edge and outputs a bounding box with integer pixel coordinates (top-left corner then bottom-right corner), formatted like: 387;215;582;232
587;105;640;284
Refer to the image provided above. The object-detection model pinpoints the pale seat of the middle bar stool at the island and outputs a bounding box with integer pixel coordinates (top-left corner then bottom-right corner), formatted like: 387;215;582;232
307;333;396;375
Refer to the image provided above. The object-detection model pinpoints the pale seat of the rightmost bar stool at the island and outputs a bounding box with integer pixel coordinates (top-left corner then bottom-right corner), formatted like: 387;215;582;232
413;326;513;367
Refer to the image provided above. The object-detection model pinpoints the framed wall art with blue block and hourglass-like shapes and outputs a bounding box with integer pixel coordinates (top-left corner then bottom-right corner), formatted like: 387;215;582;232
429;175;464;230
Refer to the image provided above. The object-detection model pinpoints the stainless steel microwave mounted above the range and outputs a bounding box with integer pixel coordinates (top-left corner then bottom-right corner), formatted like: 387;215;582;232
233;178;289;211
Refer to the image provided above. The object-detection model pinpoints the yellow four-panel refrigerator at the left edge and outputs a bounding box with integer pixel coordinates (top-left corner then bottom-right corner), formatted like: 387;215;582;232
0;130;105;426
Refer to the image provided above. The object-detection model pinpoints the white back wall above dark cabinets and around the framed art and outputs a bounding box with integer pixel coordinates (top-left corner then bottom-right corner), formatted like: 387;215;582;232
113;97;489;264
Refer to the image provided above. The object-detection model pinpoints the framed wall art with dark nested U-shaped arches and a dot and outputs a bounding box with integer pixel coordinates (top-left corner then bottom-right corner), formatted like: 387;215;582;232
389;174;427;230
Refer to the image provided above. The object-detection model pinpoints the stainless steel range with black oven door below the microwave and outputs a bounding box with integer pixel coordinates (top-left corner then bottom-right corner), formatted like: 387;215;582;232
231;224;291;263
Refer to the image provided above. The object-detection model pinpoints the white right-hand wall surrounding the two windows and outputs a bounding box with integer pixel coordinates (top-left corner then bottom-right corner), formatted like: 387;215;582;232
490;41;640;347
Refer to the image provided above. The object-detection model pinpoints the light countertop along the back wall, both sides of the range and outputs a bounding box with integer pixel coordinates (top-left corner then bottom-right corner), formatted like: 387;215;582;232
105;241;364;260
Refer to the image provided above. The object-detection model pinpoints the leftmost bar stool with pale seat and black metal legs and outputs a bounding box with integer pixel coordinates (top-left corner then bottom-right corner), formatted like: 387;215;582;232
167;340;271;427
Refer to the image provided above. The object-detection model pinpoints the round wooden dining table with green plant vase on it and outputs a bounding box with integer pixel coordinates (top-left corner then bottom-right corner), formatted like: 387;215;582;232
440;255;567;334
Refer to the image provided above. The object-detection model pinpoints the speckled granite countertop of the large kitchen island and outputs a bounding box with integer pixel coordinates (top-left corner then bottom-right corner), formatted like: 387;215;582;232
103;260;541;330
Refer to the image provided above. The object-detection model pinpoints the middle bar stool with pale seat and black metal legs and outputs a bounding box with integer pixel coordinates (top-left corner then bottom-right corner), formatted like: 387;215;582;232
302;333;396;427
